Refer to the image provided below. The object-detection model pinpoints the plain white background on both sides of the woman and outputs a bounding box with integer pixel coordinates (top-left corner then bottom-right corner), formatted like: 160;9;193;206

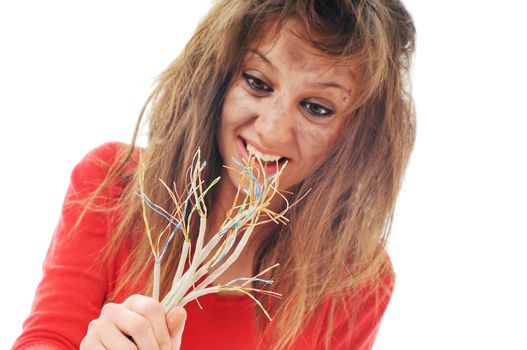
0;0;527;350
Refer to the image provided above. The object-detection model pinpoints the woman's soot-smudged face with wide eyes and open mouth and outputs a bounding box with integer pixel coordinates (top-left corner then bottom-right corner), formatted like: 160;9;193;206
217;21;355;194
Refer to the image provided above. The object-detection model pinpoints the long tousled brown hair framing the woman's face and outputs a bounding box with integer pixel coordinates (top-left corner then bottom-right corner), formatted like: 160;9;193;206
87;0;415;349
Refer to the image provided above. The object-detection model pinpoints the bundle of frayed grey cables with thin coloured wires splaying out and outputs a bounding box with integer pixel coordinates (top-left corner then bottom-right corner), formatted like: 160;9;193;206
137;149;290;320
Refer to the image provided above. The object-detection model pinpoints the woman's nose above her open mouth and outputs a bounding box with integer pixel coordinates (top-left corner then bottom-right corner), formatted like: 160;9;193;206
254;97;294;147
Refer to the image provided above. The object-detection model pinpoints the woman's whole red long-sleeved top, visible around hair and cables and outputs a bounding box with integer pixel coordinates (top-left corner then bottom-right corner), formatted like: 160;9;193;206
13;143;393;350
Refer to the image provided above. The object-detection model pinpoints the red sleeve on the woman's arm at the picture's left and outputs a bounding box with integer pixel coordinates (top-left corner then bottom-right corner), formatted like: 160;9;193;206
13;143;130;350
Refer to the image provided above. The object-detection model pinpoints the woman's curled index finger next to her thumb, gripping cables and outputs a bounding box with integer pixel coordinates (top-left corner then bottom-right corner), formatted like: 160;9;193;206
124;295;170;349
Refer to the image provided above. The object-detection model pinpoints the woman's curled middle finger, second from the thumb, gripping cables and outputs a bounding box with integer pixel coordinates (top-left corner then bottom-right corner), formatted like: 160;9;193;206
101;304;159;350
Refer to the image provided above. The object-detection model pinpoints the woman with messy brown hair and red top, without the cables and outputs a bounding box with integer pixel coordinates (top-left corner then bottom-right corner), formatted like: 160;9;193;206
14;0;415;349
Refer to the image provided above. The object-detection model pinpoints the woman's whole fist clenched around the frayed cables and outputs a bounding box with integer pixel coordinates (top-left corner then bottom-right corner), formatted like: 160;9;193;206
80;294;187;350
